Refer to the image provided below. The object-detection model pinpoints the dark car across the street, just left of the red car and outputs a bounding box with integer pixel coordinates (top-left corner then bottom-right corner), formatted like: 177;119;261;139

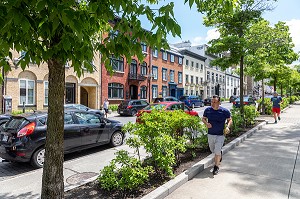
118;100;149;116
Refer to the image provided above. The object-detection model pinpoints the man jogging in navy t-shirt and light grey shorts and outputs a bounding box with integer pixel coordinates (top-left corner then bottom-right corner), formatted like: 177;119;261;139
202;96;232;175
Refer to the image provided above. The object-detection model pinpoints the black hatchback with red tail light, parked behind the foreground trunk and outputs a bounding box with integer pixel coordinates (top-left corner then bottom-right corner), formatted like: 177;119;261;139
0;109;125;168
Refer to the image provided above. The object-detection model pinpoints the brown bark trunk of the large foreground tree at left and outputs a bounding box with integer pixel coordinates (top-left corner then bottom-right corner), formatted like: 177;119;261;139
41;59;65;199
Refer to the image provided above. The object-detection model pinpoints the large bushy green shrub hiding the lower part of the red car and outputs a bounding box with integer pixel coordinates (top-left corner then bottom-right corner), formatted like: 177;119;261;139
123;110;203;176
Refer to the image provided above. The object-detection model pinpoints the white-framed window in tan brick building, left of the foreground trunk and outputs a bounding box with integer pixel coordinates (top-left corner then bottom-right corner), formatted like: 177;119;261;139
19;79;35;105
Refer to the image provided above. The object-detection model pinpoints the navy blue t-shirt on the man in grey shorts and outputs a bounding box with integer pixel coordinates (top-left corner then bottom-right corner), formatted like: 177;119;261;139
203;106;231;135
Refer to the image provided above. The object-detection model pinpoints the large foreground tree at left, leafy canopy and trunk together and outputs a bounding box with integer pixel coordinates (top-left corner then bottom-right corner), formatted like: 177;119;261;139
0;0;181;198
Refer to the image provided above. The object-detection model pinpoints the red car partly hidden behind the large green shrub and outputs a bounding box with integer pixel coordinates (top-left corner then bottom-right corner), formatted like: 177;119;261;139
136;102;198;122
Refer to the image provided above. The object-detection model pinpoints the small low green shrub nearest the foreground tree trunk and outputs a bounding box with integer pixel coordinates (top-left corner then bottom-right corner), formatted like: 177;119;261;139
98;150;153;194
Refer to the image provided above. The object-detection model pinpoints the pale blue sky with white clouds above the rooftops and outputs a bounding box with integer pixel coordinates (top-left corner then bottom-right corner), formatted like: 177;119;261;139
142;0;300;63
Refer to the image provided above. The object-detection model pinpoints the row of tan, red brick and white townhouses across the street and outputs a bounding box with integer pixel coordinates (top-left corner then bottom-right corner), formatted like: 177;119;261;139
0;40;248;112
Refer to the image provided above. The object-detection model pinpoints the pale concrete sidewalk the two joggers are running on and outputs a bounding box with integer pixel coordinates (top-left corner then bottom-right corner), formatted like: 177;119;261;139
165;103;300;199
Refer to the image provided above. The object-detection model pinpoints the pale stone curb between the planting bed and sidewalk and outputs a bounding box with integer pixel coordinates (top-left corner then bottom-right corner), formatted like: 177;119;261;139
142;122;266;199
